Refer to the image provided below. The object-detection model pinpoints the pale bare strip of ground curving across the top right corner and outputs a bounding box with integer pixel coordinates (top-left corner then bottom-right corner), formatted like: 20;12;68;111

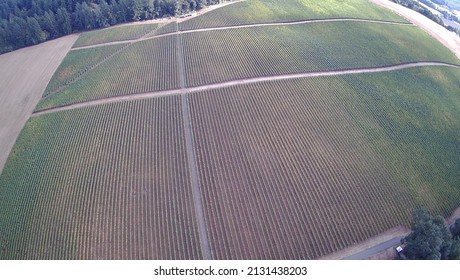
370;0;460;58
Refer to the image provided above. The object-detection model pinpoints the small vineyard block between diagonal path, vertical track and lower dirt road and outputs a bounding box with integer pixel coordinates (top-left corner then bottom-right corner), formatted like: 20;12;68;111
36;35;179;110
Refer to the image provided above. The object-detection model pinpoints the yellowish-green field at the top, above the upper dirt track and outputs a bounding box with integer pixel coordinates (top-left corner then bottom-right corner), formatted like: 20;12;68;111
180;0;407;30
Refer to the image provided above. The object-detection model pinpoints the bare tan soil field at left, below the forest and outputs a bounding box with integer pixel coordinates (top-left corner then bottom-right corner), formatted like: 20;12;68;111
0;35;78;173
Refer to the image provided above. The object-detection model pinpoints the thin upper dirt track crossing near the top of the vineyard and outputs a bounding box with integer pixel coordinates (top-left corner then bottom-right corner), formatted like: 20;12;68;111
72;18;415;51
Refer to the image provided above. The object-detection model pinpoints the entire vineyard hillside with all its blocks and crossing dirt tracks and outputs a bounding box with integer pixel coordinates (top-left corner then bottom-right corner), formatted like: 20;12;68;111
0;0;460;260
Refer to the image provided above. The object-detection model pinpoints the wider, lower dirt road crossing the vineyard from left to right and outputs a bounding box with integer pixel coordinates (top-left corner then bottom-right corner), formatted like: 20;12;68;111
31;62;460;117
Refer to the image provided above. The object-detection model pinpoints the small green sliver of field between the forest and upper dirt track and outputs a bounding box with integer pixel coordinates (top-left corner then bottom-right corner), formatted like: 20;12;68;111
73;24;160;48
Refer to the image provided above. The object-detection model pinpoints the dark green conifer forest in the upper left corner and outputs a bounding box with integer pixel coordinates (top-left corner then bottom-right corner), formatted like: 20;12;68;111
0;0;223;54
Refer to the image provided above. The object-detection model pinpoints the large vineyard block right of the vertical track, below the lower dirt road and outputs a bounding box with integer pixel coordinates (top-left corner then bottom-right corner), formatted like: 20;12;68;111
191;66;460;259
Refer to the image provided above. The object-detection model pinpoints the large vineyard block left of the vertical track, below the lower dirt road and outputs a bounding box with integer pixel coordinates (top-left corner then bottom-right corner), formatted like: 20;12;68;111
0;97;201;259
